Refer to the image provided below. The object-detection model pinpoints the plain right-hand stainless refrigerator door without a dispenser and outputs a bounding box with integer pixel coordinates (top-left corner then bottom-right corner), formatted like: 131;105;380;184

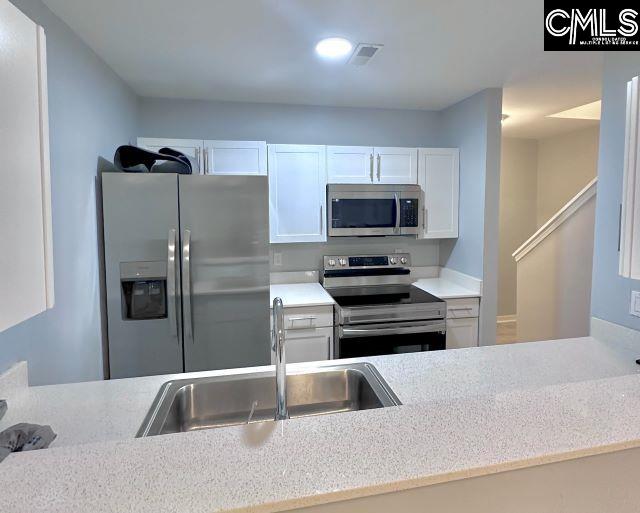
179;175;270;372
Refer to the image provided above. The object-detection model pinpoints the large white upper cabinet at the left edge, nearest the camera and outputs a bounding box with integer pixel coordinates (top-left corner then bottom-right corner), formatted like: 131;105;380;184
0;0;53;331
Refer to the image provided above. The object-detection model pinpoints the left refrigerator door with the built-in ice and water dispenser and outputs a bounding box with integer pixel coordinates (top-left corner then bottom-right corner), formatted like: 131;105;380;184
102;173;183;378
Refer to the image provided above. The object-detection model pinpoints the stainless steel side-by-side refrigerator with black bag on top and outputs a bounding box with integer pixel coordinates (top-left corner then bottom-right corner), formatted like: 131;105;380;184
102;173;270;378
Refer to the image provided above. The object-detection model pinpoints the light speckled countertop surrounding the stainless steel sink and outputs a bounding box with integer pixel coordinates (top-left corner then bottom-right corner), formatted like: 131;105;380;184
0;338;640;513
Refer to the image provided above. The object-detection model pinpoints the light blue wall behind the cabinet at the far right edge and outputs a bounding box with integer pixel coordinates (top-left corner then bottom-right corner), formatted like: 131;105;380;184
591;52;640;330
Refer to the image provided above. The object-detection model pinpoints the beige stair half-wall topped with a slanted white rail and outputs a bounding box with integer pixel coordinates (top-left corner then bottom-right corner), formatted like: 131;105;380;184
513;178;598;342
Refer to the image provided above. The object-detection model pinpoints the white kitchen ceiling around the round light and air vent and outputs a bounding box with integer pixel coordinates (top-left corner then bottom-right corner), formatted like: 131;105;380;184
44;0;602;137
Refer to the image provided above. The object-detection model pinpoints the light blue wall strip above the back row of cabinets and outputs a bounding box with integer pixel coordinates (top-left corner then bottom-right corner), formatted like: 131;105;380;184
139;98;442;146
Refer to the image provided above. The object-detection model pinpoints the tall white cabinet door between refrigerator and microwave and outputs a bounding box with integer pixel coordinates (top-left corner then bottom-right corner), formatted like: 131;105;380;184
268;144;327;242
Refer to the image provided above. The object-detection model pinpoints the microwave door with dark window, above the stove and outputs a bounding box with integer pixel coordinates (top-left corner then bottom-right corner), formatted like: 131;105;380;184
327;191;401;237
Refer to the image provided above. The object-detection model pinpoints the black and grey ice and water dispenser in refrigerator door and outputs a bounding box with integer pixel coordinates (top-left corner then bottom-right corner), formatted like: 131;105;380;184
120;262;167;321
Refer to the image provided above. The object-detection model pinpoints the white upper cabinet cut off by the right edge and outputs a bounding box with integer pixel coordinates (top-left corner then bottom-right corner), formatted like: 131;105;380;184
618;77;640;280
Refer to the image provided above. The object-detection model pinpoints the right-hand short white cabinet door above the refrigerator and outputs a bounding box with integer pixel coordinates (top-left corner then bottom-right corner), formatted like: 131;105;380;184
204;141;267;175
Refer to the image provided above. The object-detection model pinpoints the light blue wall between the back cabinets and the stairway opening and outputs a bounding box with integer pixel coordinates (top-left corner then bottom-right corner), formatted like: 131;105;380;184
440;89;502;345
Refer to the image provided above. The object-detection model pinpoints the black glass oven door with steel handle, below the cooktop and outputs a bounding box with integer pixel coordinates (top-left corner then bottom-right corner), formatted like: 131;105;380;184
335;319;447;358
